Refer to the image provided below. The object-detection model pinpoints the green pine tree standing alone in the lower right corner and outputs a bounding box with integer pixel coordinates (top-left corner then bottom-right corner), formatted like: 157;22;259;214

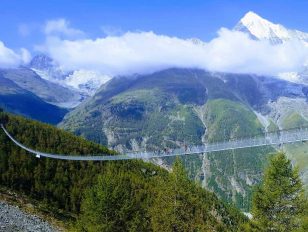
252;153;307;232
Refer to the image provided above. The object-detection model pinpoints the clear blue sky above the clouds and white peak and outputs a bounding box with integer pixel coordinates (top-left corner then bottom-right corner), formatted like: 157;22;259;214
0;0;308;50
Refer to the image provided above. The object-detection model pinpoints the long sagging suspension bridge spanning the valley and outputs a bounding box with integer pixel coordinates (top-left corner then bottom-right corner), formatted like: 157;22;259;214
1;124;308;161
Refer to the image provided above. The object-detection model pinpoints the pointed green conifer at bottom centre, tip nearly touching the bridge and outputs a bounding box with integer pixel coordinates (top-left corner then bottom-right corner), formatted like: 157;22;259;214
151;158;206;232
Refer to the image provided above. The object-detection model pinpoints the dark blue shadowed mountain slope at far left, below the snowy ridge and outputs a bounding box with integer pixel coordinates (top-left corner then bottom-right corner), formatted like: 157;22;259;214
0;75;67;124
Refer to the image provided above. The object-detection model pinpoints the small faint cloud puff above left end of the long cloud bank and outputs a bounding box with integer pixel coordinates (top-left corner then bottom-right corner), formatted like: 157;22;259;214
44;19;84;38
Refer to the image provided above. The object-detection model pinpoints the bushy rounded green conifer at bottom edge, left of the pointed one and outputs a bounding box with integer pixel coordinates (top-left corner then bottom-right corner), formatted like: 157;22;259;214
78;164;148;232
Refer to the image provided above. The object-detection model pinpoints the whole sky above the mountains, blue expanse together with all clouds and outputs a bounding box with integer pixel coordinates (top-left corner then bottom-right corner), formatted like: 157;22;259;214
0;0;308;78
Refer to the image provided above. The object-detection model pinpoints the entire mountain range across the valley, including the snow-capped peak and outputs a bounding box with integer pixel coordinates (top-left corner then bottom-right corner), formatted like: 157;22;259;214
0;12;308;210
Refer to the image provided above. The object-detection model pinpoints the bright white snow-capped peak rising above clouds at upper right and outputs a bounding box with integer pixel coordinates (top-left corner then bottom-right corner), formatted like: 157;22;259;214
234;11;308;44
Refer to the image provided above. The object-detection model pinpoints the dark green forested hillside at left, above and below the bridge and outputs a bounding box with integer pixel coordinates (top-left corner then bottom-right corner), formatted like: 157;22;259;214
0;113;113;212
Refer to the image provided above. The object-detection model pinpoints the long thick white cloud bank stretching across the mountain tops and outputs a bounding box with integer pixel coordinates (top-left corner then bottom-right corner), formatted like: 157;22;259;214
44;28;308;75
